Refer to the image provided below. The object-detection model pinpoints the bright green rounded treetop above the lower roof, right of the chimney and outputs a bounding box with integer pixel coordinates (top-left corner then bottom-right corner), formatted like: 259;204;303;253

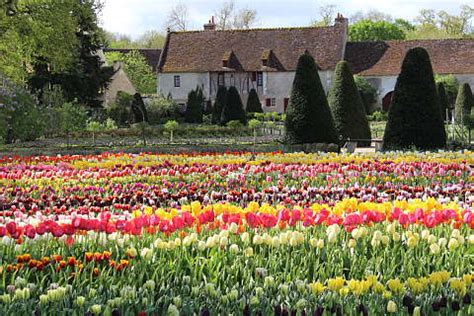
349;20;406;42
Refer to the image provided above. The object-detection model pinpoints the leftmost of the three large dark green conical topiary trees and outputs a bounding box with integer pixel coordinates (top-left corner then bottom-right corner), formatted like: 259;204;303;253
285;54;339;144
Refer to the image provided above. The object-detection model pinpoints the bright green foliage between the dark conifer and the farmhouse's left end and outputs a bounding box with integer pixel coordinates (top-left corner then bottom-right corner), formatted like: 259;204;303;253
105;50;157;94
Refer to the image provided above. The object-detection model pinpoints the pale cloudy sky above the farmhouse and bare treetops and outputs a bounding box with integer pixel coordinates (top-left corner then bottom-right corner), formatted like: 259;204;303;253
102;0;474;37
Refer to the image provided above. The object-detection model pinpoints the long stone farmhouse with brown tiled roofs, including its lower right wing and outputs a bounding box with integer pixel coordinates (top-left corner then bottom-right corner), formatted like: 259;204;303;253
157;15;474;113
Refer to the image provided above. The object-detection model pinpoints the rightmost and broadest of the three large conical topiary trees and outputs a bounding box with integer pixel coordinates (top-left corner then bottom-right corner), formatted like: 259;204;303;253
383;47;446;150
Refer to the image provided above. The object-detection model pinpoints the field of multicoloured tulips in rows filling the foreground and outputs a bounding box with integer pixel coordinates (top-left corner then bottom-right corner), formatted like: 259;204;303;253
0;151;474;315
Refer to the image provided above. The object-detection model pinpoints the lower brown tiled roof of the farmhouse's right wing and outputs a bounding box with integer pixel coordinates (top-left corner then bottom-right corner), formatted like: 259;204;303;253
345;39;474;76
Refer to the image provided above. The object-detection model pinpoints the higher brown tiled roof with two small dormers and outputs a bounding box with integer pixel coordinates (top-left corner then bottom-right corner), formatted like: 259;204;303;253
159;23;346;72
